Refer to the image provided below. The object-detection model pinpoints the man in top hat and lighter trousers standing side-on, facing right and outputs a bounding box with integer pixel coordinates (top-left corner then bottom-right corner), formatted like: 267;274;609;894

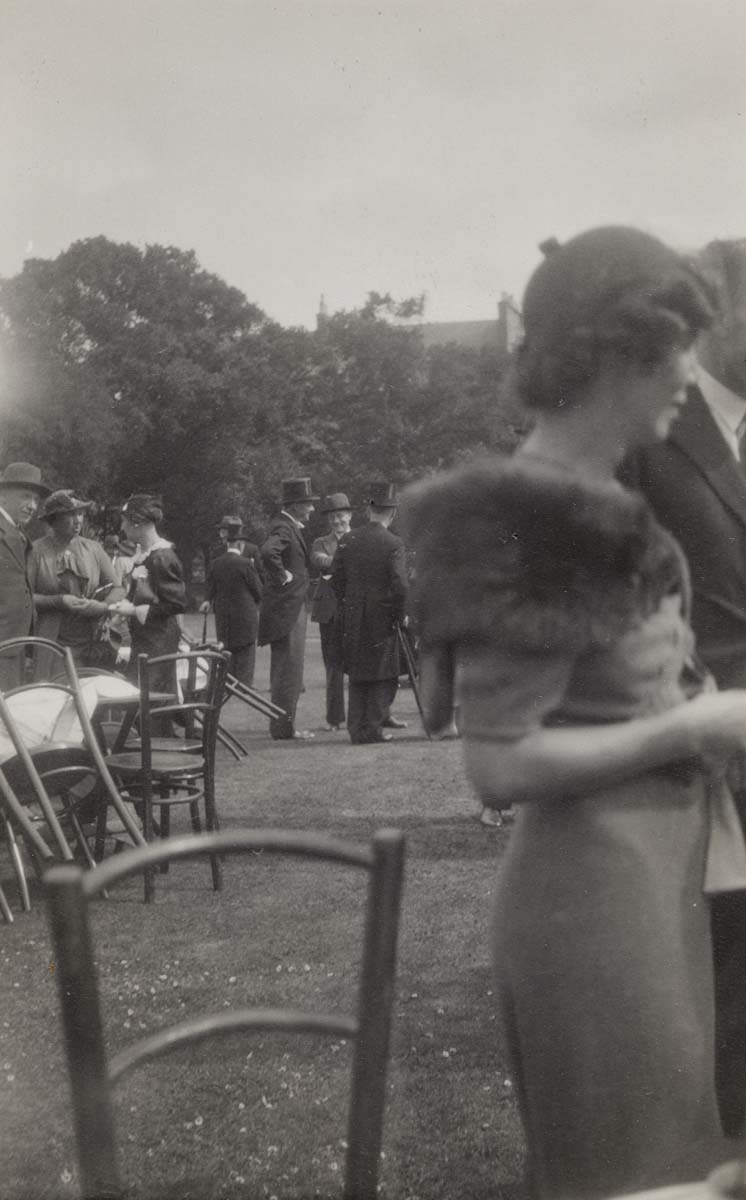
259;479;318;740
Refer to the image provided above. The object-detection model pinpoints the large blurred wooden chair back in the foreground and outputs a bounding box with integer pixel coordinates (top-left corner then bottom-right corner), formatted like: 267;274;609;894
44;829;404;1200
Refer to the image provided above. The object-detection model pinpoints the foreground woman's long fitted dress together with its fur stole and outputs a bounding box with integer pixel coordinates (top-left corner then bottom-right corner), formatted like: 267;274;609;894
405;460;743;1200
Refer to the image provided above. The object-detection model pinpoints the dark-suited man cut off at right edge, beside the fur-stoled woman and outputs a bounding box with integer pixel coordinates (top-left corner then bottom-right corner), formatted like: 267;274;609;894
622;240;746;1136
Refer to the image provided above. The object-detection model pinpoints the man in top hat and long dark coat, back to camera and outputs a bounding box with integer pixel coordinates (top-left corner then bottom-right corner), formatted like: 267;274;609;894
331;482;408;745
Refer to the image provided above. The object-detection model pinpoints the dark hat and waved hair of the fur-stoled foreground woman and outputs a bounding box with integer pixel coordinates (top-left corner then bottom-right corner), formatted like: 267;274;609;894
515;226;714;409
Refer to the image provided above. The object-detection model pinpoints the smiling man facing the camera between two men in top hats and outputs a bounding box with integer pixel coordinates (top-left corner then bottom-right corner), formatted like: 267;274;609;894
311;492;353;731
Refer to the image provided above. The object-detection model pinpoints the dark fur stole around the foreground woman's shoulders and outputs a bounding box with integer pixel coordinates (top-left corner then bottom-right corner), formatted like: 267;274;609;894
402;455;686;653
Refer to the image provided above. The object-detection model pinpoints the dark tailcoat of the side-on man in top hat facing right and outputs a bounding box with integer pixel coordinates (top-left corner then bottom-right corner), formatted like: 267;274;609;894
259;512;311;646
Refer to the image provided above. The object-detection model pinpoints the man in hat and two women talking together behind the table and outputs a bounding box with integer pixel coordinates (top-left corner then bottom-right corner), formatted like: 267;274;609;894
0;482;186;691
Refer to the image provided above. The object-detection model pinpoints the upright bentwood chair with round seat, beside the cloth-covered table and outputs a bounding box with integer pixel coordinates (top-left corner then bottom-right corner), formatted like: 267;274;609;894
107;650;228;902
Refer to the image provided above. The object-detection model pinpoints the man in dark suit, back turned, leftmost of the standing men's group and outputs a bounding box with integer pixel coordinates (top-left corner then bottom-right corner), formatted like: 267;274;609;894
200;522;261;688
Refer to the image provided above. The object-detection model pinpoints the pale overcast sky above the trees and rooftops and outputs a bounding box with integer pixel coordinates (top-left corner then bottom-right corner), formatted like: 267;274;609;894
0;0;746;325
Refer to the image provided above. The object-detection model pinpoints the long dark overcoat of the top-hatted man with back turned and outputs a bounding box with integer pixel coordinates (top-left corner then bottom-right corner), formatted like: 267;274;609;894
332;521;407;682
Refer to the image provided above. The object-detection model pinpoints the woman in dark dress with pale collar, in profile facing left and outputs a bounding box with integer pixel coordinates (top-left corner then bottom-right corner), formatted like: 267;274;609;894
112;494;186;695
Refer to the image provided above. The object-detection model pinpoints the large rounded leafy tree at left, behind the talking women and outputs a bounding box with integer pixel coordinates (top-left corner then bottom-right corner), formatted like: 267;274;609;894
0;238;267;570
